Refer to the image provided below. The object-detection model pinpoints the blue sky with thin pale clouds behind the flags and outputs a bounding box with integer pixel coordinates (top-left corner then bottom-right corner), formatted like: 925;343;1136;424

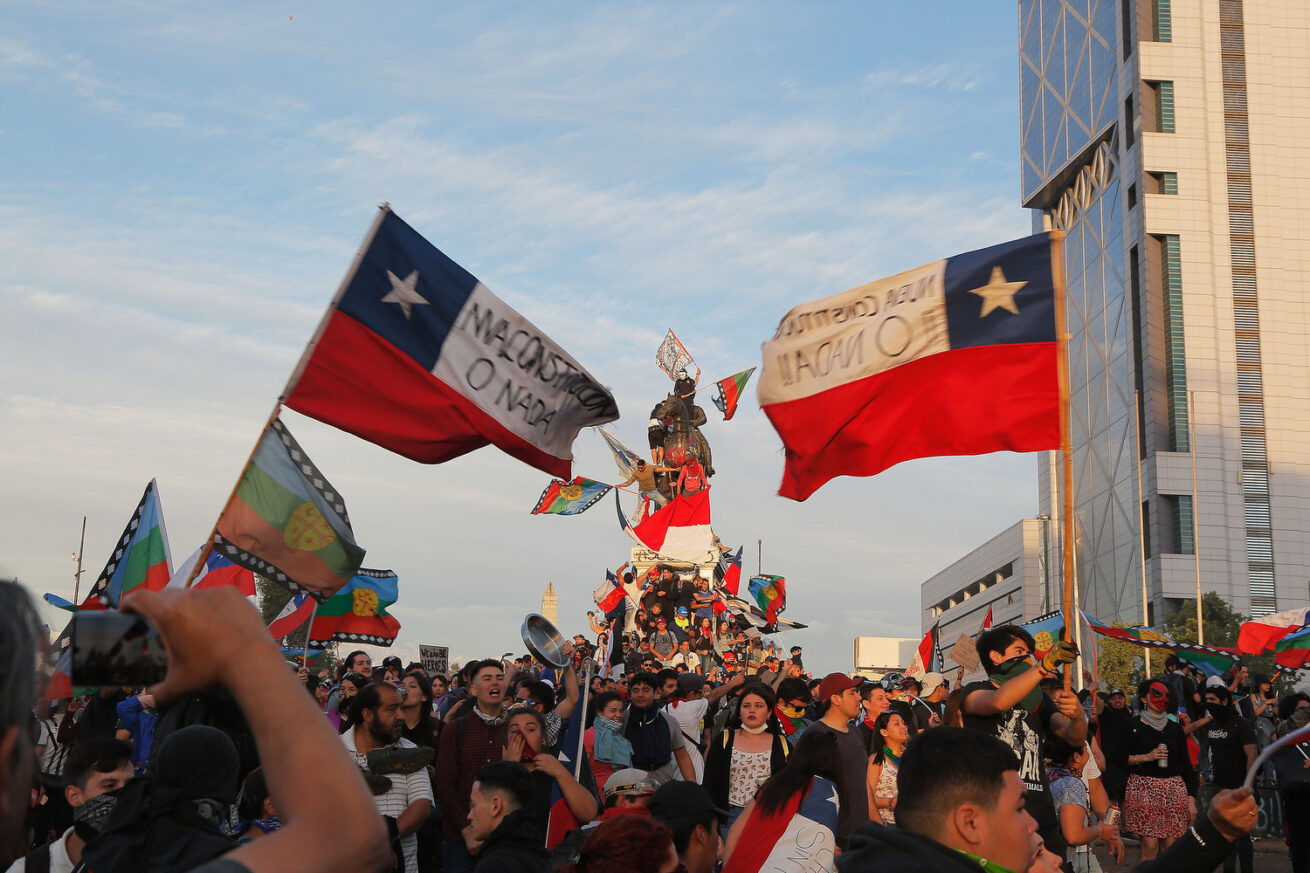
0;0;1036;669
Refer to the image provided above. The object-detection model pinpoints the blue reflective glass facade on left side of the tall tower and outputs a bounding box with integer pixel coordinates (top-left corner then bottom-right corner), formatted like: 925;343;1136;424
1019;0;1142;621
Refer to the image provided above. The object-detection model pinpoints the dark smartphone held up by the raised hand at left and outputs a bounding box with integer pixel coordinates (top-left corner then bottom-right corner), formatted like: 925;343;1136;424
69;610;168;687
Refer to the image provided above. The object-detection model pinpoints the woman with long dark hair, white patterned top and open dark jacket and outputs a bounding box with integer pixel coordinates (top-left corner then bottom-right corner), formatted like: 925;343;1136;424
701;682;791;834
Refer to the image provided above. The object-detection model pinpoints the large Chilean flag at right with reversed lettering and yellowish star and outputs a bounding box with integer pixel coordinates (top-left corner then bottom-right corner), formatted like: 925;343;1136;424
758;233;1060;501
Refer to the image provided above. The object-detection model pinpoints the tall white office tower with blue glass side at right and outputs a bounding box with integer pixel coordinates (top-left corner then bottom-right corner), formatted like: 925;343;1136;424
1018;0;1310;623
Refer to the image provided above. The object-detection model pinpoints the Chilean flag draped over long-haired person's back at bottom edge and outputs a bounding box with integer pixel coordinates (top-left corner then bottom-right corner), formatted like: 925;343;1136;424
723;776;840;873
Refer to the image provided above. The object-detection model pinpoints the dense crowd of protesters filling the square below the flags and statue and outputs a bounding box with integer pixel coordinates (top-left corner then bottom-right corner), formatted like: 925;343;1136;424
0;568;1310;873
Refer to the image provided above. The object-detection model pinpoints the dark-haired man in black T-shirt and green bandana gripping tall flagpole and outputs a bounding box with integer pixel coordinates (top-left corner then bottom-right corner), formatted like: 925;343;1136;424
960;624;1087;856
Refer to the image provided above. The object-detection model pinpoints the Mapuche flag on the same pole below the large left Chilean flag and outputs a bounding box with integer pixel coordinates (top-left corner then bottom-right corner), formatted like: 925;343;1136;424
214;421;364;600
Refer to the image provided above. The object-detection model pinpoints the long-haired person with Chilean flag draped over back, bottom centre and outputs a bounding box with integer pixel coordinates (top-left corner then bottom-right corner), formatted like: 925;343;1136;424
723;731;841;873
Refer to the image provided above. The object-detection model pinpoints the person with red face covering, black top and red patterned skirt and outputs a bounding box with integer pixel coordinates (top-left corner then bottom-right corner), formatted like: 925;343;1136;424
1117;679;1197;860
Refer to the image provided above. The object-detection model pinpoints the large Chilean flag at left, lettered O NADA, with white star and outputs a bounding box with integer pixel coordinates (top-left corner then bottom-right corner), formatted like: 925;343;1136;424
283;206;618;478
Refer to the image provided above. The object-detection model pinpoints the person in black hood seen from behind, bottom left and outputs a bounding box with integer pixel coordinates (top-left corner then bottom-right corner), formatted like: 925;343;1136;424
83;725;240;873
